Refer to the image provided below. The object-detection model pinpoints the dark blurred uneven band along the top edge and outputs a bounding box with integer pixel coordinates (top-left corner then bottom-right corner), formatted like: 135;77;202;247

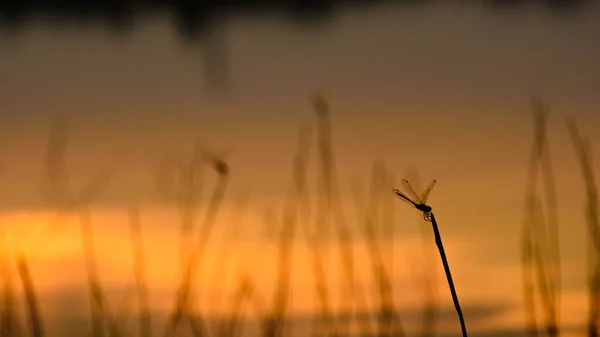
0;0;592;38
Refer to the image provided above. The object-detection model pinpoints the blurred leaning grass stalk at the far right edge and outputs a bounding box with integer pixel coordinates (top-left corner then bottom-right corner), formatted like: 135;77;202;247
567;119;600;337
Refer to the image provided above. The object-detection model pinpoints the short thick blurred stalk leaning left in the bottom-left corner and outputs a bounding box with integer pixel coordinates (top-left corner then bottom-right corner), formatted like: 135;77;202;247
16;254;44;337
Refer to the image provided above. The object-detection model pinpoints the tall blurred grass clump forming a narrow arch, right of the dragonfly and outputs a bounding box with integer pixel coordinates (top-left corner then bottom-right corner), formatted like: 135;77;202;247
521;97;561;337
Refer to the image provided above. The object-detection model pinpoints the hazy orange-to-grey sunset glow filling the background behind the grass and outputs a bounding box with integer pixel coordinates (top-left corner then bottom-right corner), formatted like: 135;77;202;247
0;3;600;336
